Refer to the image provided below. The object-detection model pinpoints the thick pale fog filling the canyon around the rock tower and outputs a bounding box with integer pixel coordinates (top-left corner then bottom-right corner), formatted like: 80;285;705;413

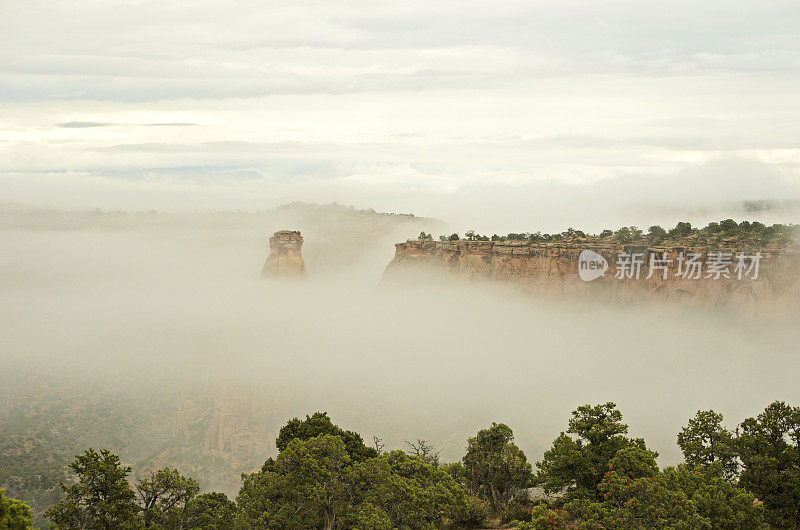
0;205;800;486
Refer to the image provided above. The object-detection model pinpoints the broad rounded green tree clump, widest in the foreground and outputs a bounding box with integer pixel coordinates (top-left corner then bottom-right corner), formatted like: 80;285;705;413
237;434;474;528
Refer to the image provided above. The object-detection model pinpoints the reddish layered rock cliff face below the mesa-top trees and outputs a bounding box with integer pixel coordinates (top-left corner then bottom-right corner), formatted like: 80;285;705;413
383;239;800;314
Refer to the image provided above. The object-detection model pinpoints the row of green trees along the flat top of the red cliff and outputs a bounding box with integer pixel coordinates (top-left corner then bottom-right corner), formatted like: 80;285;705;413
418;219;800;247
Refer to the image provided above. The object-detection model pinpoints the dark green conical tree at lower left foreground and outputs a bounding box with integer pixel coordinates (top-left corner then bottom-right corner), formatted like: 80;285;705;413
45;448;141;530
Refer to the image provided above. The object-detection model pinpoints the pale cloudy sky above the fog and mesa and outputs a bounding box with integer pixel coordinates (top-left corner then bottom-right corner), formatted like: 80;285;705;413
0;0;800;233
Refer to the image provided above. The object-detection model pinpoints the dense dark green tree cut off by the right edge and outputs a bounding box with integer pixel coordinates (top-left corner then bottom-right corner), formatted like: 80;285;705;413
736;401;800;527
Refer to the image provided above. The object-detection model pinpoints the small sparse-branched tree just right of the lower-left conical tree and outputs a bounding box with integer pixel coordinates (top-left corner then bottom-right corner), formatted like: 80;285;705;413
136;468;200;529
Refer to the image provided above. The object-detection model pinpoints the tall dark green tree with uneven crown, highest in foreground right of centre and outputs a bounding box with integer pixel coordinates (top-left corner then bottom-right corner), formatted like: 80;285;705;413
536;402;658;499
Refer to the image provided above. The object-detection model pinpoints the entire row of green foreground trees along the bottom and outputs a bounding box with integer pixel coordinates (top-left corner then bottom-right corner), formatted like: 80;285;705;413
0;402;800;529
